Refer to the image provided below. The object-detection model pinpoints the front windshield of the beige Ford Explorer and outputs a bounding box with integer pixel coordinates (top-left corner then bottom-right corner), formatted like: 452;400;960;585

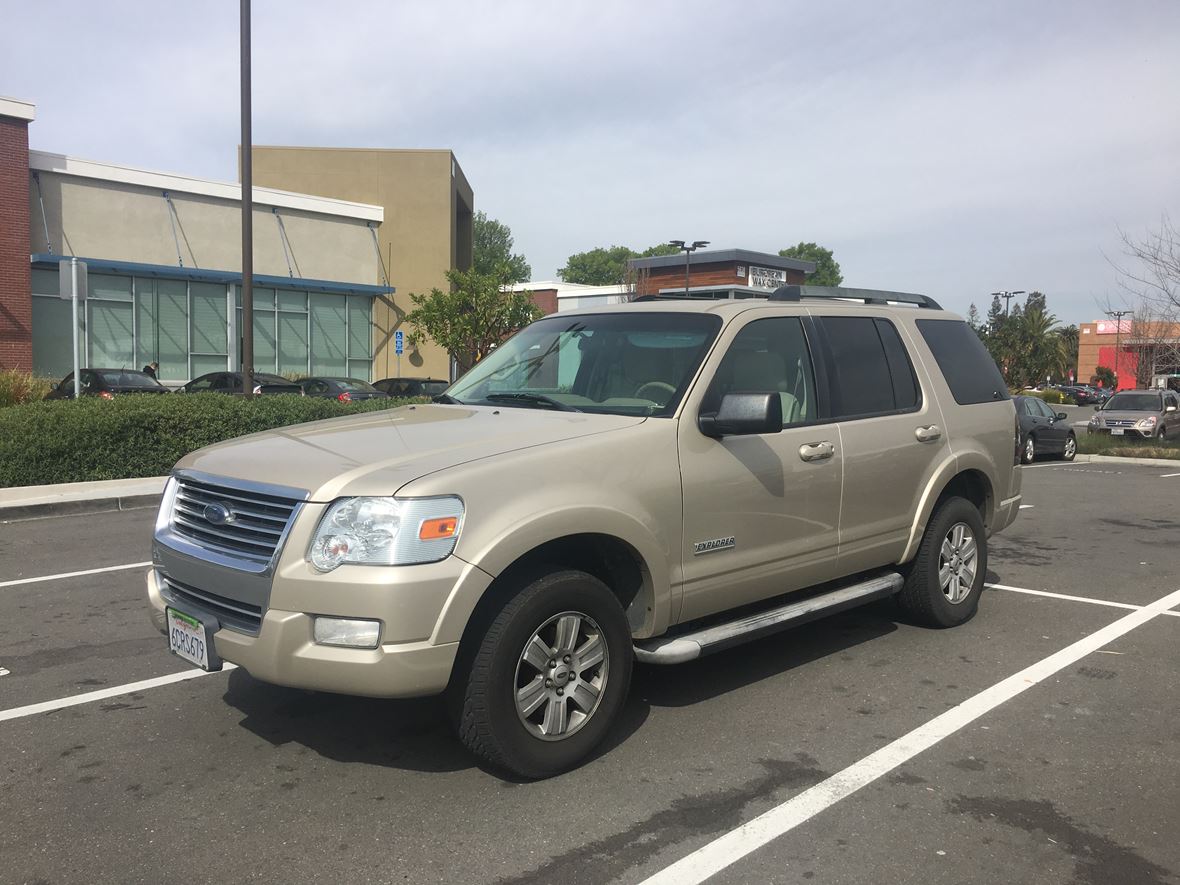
447;312;721;418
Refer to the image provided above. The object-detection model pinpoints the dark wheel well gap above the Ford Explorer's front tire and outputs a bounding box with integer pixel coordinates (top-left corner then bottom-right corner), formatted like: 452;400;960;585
452;533;654;698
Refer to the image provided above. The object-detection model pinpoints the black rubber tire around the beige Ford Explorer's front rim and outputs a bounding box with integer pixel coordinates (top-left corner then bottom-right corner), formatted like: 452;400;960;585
453;570;635;778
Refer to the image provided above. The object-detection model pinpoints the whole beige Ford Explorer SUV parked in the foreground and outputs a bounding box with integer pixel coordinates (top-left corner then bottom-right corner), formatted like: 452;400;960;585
148;287;1021;776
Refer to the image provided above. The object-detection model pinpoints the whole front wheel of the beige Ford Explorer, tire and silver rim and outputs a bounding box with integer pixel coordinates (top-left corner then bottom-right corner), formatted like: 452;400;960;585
458;570;634;778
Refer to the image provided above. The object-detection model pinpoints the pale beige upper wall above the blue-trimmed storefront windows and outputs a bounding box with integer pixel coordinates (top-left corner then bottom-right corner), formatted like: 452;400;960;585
30;171;382;286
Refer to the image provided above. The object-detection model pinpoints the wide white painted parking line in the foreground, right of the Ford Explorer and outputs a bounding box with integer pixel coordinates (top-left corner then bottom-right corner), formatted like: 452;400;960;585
642;590;1180;885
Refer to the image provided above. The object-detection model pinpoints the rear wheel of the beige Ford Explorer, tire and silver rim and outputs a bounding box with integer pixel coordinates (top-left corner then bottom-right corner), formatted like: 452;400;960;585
898;498;988;627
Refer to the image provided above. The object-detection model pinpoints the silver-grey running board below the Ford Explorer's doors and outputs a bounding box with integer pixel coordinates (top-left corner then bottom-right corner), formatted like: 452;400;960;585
635;572;904;664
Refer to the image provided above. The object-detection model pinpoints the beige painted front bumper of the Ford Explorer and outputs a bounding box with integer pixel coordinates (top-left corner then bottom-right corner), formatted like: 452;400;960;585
153;569;469;697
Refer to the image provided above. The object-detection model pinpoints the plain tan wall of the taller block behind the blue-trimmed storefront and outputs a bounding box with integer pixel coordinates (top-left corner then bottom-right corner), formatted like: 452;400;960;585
254;146;474;379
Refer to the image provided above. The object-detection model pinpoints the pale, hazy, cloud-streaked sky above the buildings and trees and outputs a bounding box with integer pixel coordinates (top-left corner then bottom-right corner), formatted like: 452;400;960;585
0;0;1180;322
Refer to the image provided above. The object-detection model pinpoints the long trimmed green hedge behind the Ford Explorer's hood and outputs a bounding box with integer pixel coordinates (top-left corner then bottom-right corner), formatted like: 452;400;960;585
0;393;425;487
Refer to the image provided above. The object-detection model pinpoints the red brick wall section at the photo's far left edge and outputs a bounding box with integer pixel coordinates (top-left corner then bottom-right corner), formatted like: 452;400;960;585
0;117;33;372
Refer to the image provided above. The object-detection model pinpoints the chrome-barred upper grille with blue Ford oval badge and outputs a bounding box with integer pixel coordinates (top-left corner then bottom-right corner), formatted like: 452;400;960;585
172;477;300;563
